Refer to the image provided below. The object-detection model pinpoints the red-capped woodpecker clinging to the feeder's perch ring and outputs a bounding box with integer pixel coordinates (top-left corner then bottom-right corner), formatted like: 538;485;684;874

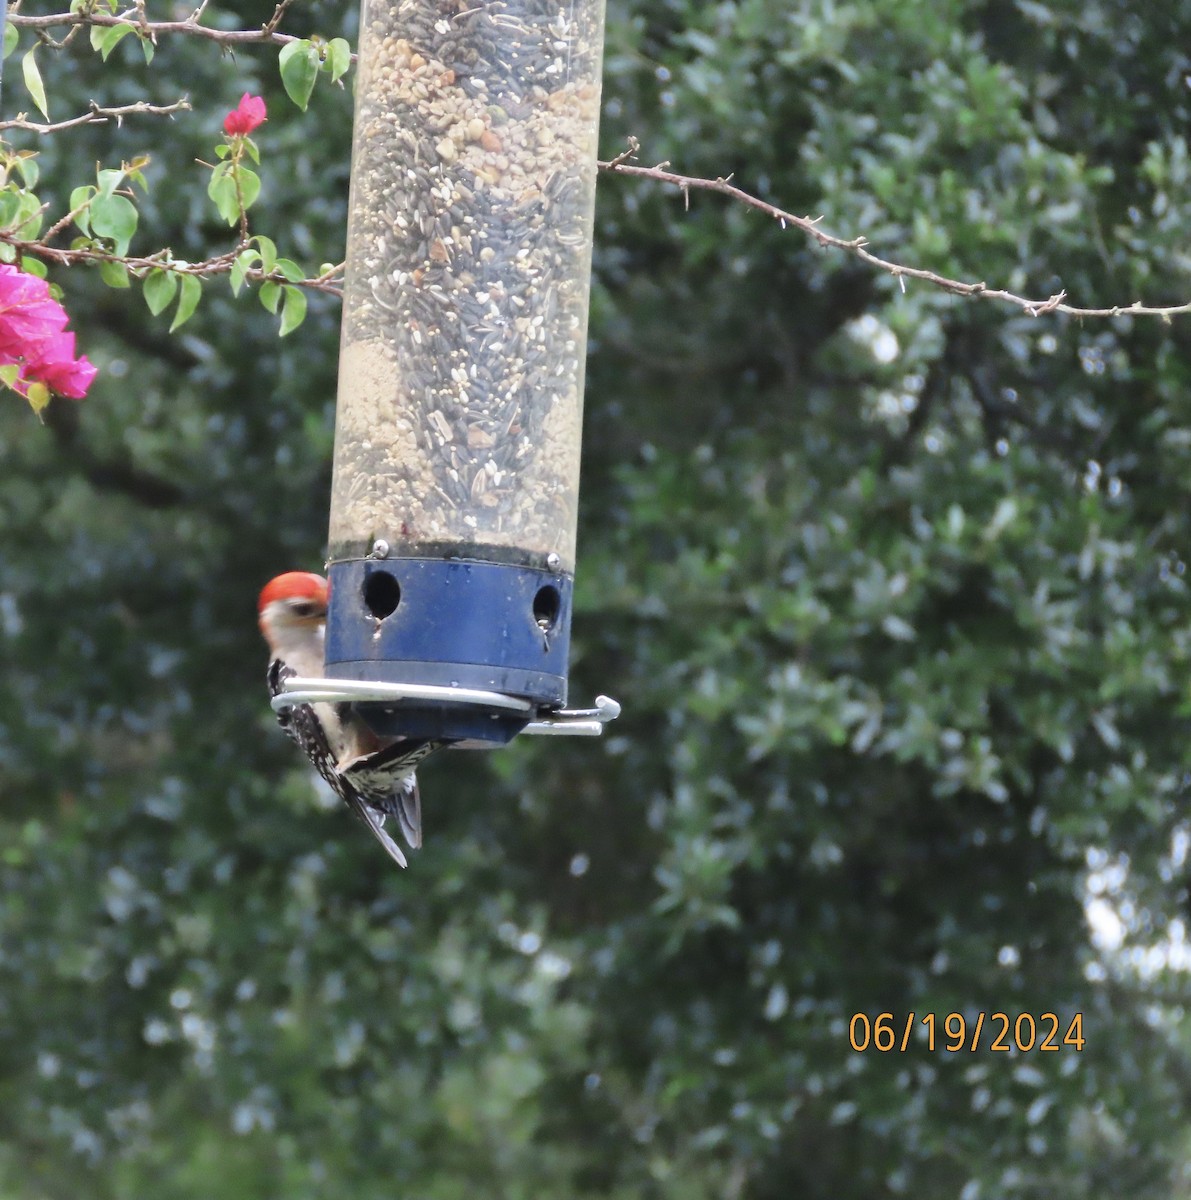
257;571;438;866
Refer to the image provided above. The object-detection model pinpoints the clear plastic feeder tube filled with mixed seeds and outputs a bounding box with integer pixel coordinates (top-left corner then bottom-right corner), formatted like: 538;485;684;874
329;0;604;572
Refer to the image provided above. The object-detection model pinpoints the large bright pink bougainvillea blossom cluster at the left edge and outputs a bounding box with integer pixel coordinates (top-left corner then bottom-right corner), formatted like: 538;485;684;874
0;263;96;407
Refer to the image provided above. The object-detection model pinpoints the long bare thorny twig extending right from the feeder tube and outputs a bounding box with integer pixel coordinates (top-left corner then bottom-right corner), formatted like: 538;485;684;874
599;138;1191;320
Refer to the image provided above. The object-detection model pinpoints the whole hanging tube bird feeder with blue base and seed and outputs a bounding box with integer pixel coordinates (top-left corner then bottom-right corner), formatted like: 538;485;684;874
302;0;618;745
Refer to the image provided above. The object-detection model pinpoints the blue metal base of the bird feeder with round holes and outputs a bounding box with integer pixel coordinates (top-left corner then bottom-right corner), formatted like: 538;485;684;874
325;558;573;745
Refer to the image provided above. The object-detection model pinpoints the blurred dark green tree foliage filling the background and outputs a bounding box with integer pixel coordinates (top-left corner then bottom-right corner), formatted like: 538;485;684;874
0;0;1191;1200
